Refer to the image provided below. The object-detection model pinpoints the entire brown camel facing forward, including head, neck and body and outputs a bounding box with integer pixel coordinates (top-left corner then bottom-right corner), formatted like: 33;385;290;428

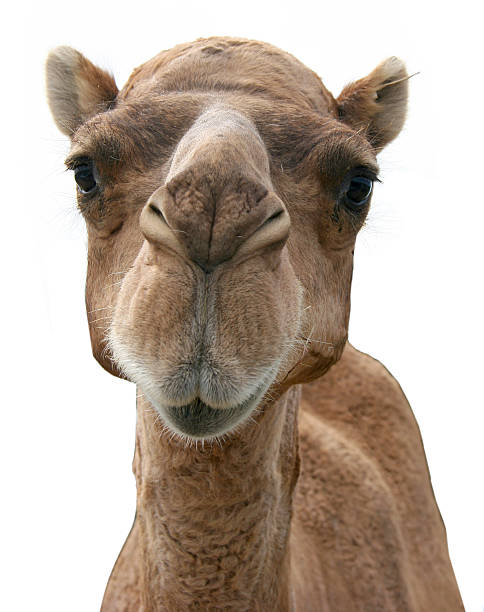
47;37;464;612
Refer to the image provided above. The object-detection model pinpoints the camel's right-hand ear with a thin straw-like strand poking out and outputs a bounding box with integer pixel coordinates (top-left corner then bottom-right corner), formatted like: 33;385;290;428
337;57;409;151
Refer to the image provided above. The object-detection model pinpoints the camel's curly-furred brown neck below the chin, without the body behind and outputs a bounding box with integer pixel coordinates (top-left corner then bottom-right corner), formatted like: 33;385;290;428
134;388;299;612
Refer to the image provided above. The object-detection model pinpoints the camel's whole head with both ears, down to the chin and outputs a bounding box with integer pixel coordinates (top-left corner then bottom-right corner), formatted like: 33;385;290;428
47;38;407;439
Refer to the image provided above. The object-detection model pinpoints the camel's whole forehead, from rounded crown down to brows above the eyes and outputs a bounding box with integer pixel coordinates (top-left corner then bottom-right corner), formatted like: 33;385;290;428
73;38;374;177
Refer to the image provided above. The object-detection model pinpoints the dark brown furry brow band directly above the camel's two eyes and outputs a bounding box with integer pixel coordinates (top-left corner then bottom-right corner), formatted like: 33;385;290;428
72;92;375;178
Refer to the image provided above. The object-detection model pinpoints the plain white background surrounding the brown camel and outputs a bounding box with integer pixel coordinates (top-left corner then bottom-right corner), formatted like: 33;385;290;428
0;0;484;612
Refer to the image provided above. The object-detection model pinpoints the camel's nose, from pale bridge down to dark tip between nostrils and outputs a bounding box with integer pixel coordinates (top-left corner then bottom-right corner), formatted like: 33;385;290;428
141;110;282;268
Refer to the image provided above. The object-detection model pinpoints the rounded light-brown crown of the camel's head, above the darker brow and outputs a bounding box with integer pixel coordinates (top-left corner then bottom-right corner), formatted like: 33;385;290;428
119;37;335;114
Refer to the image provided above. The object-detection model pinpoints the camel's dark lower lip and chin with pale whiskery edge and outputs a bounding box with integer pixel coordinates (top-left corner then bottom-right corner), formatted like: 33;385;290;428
157;385;266;440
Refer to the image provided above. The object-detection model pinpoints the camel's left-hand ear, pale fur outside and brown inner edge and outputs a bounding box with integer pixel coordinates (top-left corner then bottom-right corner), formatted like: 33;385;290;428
46;47;118;136
